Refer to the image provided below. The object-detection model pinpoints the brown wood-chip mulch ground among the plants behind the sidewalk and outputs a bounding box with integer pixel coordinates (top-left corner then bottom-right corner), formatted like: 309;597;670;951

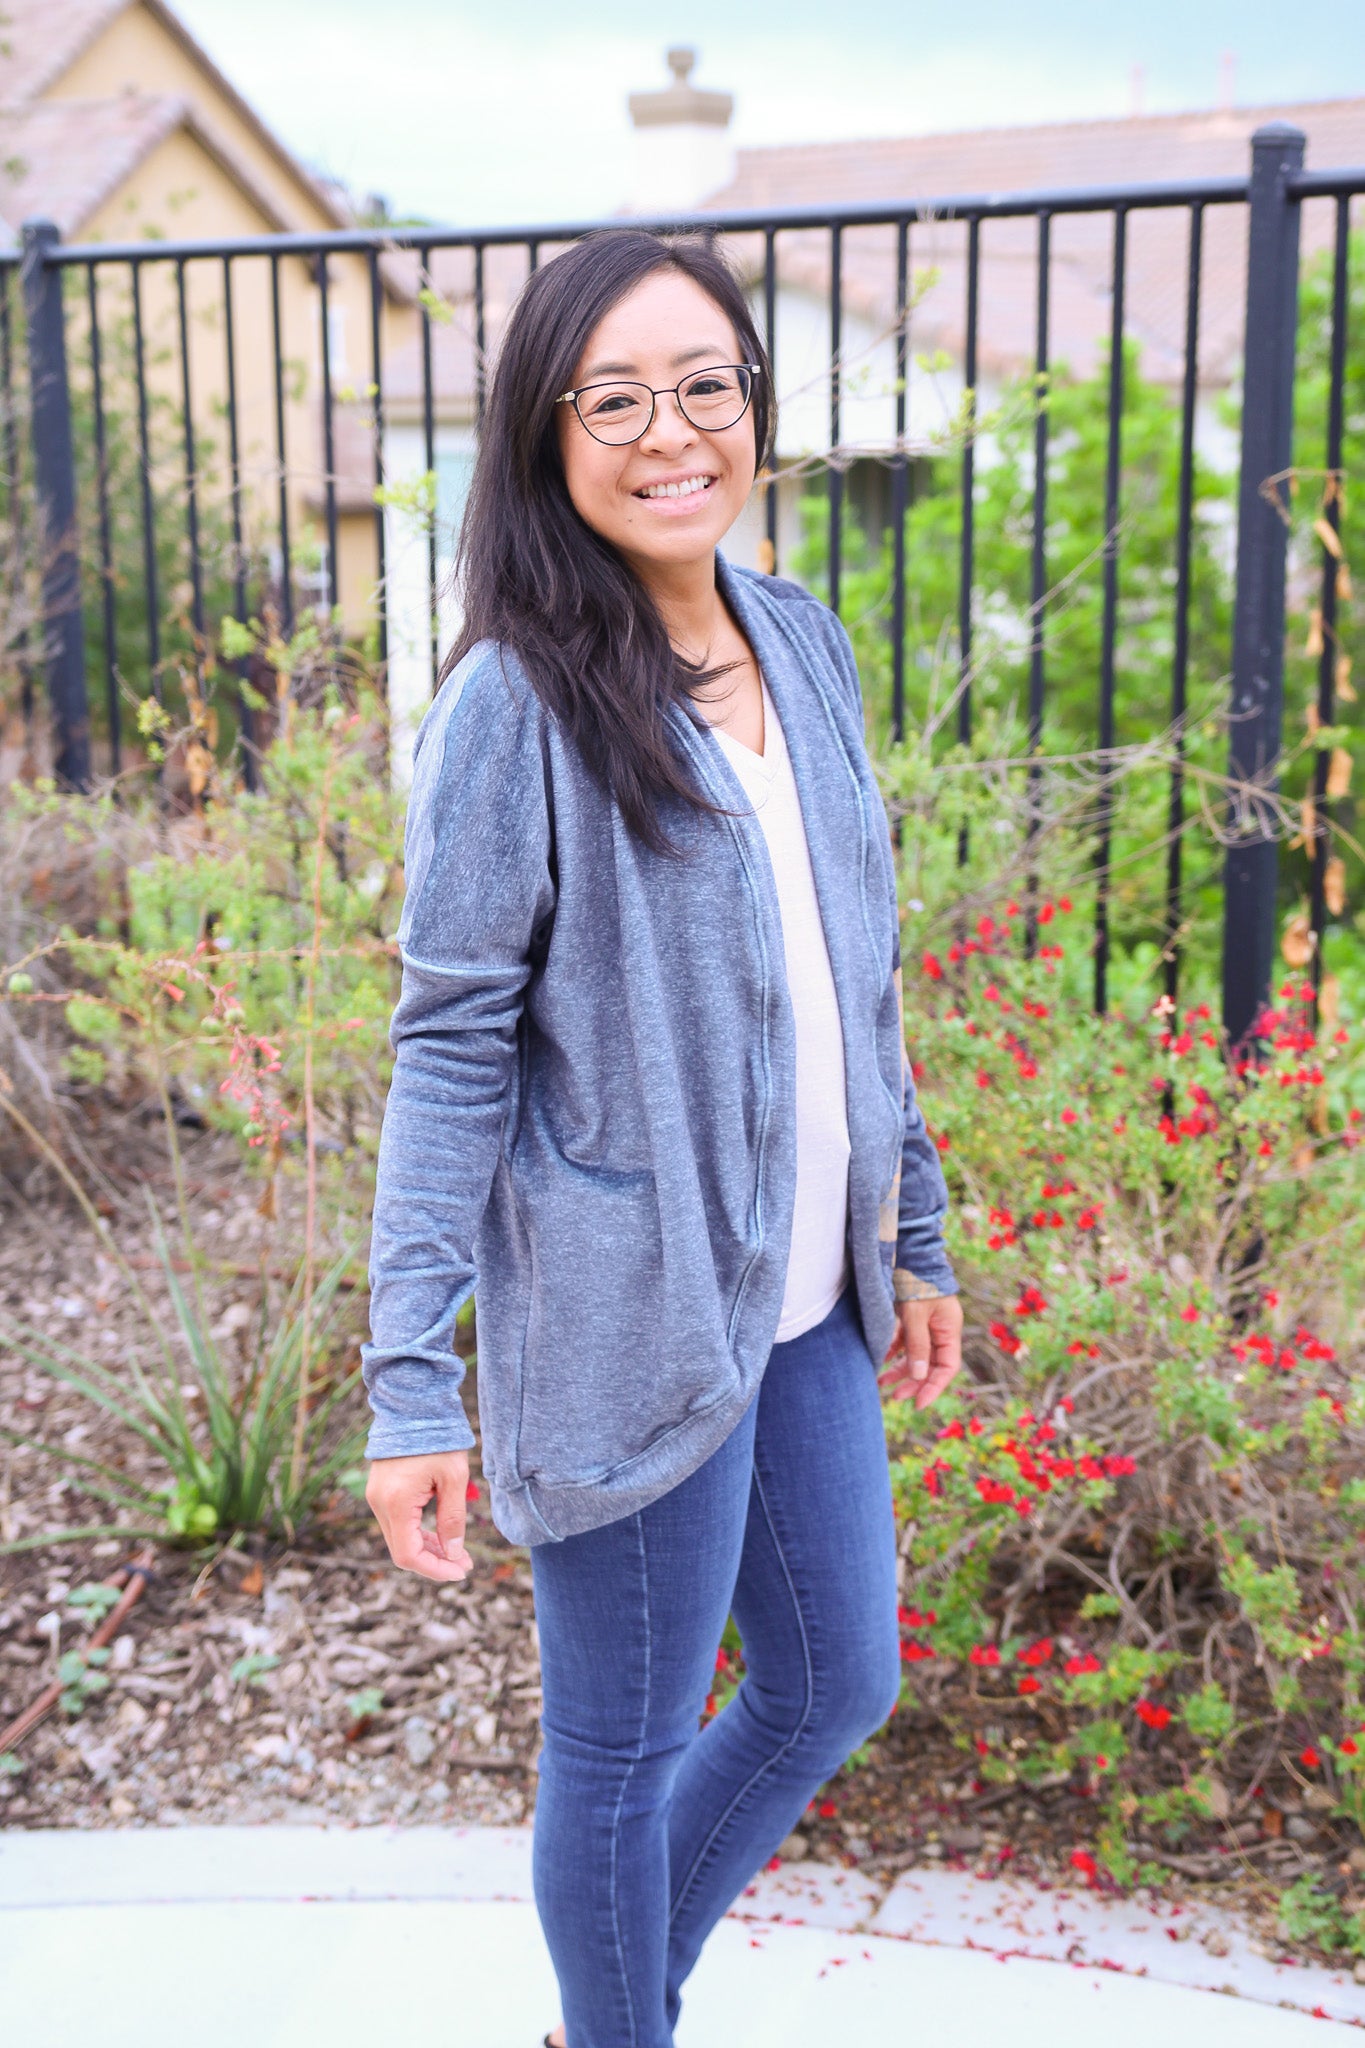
0;1135;1365;1954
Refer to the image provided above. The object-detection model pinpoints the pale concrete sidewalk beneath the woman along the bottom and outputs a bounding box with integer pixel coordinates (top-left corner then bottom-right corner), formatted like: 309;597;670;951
0;1827;1365;2048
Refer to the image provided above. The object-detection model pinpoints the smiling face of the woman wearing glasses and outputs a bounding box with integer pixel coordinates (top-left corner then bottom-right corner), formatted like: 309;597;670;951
557;270;755;575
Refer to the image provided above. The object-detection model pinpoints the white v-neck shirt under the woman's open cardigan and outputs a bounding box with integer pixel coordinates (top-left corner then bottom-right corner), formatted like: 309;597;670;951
712;684;849;1343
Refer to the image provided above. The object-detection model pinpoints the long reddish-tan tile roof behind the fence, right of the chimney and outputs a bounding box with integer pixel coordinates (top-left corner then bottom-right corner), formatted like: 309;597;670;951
706;98;1365;383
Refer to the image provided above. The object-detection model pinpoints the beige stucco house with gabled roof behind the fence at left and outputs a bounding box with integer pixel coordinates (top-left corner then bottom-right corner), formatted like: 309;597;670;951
0;0;413;627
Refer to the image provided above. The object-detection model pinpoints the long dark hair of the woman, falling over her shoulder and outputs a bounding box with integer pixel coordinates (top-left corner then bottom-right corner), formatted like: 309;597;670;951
442;227;772;852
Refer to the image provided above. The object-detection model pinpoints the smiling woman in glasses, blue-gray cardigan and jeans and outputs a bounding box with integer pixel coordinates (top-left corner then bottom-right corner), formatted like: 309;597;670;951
364;229;962;2048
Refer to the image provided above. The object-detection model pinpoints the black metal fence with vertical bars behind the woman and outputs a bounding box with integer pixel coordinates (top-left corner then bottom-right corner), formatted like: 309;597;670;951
0;127;1365;1038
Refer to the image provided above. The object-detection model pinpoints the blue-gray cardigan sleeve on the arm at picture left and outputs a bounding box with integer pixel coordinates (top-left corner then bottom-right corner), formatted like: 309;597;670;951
362;647;555;1458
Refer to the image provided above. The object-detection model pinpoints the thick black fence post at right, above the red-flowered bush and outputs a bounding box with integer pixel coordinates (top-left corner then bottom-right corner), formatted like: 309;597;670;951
1224;121;1304;1044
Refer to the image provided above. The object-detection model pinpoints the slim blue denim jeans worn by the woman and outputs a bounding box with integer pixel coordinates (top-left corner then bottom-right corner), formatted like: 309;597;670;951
532;1288;900;2048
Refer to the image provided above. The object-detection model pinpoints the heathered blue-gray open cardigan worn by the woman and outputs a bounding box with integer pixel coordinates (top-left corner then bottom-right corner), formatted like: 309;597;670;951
362;563;956;1544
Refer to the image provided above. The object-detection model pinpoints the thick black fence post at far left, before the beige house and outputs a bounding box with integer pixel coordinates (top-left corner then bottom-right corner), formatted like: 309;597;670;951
23;221;90;788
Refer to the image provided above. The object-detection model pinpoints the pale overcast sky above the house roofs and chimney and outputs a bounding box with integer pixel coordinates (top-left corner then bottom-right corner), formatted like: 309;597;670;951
176;0;1365;225
